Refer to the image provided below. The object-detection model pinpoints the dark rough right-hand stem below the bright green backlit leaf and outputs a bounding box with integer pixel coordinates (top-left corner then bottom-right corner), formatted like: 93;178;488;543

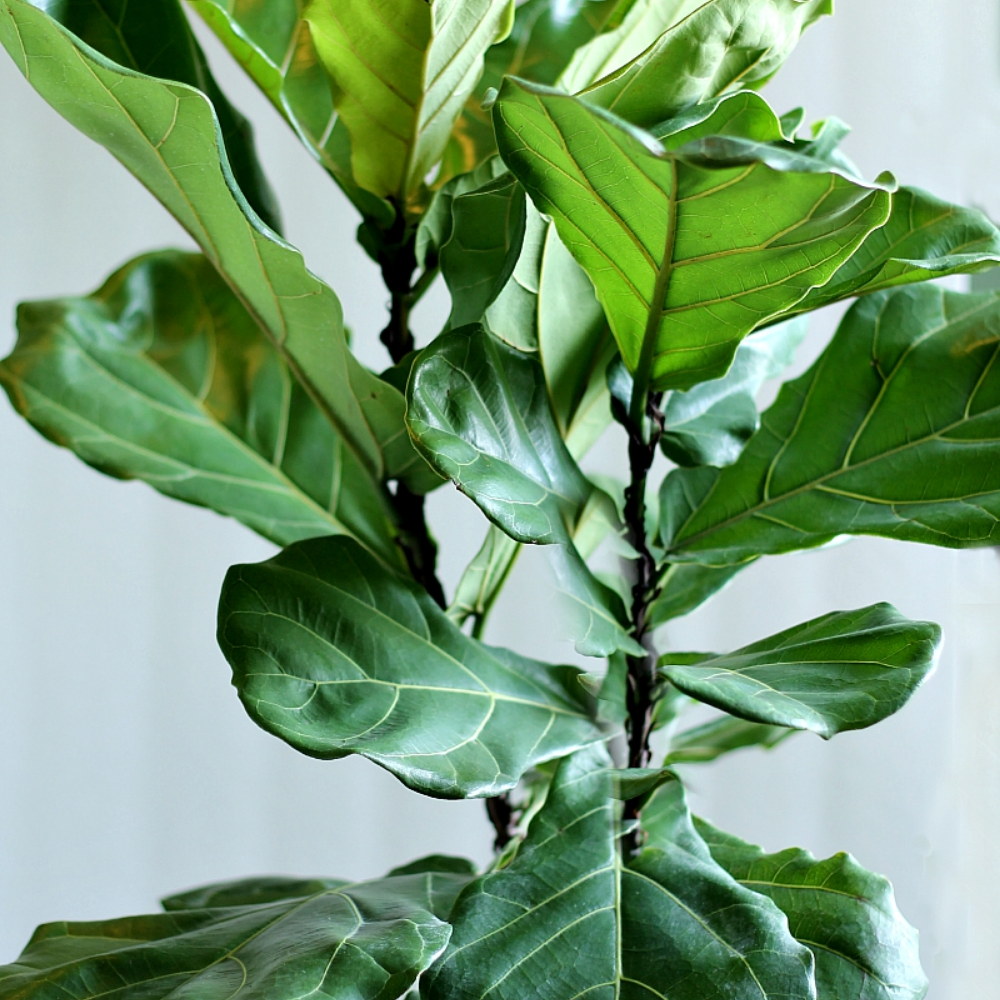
622;393;663;856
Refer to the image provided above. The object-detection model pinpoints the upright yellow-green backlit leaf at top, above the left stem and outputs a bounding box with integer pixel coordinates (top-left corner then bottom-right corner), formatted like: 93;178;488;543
305;0;510;205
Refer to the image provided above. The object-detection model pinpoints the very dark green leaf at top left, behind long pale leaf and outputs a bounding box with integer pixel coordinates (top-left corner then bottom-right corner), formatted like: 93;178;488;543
38;0;280;231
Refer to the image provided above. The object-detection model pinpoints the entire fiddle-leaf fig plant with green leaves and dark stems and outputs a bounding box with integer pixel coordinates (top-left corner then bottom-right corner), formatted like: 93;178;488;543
0;0;1000;1000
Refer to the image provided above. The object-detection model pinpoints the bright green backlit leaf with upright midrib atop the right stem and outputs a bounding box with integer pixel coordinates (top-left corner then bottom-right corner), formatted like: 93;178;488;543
494;80;891;398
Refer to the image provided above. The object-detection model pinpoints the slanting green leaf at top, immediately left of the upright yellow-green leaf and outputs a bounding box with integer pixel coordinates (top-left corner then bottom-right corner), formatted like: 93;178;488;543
188;0;395;228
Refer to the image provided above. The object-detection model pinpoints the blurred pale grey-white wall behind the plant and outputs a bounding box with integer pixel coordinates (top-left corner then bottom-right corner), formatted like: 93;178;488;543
0;0;1000;1000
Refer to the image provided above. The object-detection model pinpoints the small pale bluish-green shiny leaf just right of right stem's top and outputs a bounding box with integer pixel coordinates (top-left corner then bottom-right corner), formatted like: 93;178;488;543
660;318;808;467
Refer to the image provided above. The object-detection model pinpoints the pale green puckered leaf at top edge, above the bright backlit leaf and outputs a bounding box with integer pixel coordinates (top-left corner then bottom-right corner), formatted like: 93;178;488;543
563;0;833;127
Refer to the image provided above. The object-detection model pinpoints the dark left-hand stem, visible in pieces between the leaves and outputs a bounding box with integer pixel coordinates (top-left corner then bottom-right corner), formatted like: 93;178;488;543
378;212;514;851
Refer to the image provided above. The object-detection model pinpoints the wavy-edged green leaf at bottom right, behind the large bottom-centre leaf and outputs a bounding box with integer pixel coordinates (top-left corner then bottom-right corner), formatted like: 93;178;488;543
695;820;927;1000
